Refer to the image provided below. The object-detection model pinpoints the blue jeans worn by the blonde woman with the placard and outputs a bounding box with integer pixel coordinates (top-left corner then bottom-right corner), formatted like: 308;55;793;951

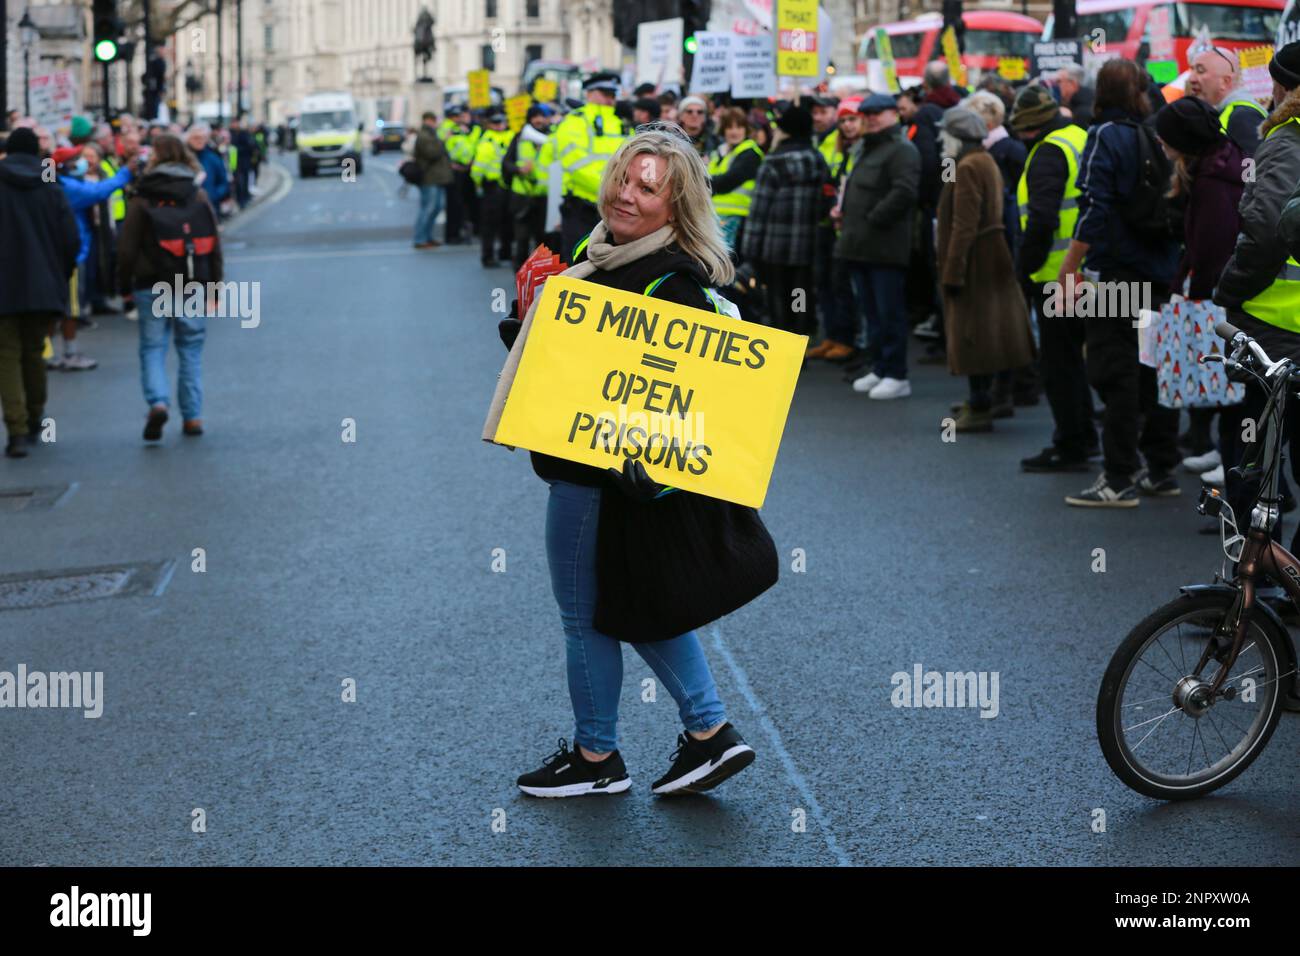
546;481;727;753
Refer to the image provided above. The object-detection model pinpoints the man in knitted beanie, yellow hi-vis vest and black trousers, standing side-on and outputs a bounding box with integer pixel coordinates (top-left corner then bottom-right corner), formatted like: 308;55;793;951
1010;85;1097;472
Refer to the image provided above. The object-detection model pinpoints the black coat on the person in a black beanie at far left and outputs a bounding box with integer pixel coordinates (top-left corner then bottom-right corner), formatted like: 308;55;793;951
0;153;81;315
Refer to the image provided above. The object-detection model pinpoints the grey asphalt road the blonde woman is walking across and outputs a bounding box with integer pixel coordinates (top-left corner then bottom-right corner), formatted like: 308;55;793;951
0;153;1300;865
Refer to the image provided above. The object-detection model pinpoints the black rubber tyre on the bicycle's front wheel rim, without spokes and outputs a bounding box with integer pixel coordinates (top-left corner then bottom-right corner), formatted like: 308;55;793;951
1097;593;1287;800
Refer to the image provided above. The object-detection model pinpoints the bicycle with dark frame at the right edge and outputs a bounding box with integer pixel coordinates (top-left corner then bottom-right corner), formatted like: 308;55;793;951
1097;321;1300;800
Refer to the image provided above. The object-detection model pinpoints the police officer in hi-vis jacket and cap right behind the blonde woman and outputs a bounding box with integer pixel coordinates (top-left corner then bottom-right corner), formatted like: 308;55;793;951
554;72;628;261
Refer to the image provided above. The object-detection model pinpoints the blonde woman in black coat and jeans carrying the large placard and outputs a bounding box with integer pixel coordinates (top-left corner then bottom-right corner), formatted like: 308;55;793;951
502;124;776;797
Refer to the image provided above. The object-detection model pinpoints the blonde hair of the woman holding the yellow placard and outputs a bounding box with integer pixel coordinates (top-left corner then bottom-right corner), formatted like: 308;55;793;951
599;122;736;286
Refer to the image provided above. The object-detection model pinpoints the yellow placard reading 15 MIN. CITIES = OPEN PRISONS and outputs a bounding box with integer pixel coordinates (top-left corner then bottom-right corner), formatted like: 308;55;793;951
485;276;807;507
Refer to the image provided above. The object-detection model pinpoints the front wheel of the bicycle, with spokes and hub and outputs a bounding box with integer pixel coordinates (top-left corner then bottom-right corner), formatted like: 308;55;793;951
1097;592;1290;800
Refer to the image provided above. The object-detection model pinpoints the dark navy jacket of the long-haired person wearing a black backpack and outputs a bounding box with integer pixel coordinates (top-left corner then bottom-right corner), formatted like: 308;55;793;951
1074;109;1178;285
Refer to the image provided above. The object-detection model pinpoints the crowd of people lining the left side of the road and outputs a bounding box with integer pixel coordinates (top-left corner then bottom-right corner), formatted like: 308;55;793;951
0;111;256;458
